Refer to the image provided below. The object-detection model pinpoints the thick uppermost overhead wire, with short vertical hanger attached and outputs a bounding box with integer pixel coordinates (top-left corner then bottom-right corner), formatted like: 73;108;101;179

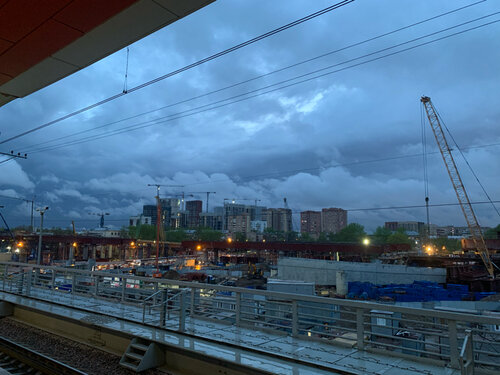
0;0;354;144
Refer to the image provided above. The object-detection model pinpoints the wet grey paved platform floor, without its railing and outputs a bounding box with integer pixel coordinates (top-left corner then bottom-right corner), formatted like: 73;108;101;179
0;288;460;375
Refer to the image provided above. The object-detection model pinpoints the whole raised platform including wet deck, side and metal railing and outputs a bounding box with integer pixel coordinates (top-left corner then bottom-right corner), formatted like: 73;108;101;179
0;262;500;375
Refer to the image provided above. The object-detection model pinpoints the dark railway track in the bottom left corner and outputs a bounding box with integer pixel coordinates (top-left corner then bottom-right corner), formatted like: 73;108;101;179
0;336;85;375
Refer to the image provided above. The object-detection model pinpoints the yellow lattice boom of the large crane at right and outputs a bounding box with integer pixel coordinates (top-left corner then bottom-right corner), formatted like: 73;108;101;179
420;96;495;278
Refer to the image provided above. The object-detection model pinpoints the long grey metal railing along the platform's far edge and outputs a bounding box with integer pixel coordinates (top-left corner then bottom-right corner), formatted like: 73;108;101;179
0;263;500;374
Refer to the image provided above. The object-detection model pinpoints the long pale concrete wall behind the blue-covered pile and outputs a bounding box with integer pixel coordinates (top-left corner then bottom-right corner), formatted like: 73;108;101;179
278;258;446;285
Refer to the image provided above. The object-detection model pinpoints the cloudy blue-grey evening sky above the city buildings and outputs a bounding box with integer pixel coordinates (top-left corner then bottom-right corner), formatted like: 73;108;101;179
0;0;500;230
